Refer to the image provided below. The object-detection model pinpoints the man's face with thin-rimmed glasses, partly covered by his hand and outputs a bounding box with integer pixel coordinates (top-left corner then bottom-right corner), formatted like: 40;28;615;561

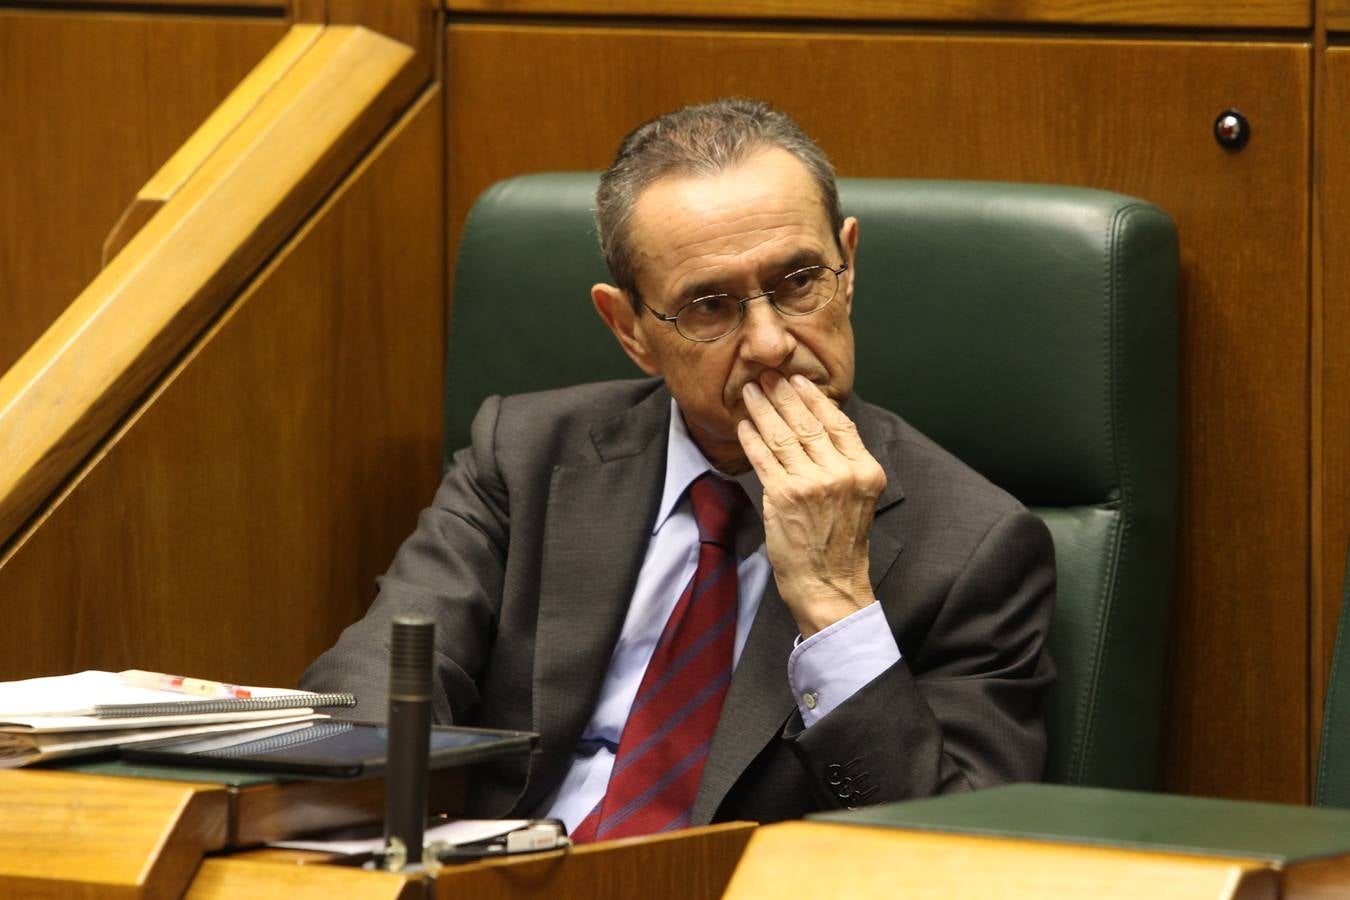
593;148;857;471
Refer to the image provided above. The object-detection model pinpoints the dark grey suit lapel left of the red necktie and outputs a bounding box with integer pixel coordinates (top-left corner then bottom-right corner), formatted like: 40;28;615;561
532;389;670;784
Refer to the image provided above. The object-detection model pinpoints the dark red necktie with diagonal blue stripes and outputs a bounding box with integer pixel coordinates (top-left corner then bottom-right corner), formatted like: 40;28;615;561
572;472;749;842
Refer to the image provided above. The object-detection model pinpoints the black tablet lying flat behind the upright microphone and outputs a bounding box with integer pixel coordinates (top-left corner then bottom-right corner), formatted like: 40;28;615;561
122;719;537;779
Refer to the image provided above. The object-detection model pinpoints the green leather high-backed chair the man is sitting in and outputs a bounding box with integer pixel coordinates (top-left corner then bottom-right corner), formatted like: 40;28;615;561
446;173;1177;788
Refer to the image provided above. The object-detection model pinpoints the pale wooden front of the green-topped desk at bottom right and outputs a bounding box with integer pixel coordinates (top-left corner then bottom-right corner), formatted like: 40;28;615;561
725;822;1281;900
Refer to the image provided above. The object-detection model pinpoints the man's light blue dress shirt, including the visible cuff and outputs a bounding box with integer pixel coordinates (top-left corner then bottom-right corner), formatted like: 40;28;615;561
536;401;900;830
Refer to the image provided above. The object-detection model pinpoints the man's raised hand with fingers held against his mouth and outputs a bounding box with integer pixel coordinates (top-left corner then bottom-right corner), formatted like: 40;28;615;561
737;372;886;637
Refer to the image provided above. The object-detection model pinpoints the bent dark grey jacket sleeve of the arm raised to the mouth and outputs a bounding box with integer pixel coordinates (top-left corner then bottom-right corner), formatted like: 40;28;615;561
784;510;1054;808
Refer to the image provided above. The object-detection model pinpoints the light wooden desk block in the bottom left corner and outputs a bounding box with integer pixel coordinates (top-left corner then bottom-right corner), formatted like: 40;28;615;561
0;769;228;900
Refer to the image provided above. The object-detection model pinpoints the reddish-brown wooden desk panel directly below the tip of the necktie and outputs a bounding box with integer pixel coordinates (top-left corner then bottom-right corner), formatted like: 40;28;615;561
435;822;756;900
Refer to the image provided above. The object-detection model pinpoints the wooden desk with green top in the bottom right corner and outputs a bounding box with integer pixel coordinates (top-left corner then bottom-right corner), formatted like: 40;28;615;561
726;784;1350;900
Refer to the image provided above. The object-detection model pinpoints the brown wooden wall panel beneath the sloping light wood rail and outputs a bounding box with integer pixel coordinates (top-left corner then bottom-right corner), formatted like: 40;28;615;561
0;92;444;684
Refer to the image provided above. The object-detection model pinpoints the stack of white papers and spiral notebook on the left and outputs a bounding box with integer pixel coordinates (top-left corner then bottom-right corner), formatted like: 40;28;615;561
0;671;355;768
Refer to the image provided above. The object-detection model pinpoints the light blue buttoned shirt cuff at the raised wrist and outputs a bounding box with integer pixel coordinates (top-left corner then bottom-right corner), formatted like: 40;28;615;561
787;603;900;727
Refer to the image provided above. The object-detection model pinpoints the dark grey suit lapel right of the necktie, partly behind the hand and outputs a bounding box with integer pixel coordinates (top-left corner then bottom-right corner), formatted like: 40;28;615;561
690;398;905;824
